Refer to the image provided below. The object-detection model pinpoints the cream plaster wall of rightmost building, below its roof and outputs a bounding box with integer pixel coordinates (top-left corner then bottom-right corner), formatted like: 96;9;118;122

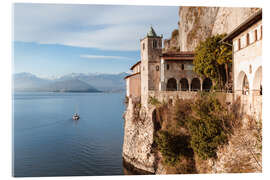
233;22;262;94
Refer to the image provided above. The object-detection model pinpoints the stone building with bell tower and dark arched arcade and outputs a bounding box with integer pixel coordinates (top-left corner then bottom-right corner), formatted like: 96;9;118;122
125;27;212;105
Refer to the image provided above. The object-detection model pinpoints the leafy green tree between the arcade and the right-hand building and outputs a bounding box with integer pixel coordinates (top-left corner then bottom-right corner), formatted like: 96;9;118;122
193;34;232;87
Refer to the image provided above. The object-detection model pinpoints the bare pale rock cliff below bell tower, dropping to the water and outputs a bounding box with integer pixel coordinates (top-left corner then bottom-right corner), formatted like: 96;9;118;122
122;98;156;173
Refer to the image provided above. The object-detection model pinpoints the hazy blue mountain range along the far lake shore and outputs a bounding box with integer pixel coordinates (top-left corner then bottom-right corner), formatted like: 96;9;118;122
13;72;129;92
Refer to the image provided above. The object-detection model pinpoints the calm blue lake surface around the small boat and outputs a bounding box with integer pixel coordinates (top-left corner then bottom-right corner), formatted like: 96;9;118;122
13;93;125;177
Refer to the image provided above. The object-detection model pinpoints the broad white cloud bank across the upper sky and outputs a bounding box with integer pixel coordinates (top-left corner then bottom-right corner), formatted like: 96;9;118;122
14;4;178;50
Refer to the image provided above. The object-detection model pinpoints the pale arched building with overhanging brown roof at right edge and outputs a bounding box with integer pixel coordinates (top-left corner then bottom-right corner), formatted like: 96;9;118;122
223;9;262;118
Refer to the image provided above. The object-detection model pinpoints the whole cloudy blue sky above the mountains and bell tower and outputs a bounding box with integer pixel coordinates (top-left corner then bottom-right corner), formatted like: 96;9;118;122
13;3;179;77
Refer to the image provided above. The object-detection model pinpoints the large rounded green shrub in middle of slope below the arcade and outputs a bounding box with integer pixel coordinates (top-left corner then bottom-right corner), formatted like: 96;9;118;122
187;94;230;159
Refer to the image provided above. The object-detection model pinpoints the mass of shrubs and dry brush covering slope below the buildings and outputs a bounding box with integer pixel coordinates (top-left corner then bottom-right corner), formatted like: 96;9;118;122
149;93;262;174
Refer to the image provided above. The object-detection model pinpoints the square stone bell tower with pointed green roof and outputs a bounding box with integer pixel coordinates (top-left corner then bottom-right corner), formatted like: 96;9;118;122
140;26;162;104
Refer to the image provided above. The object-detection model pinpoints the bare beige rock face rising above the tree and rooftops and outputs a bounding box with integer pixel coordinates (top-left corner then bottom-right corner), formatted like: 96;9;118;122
175;7;259;51
